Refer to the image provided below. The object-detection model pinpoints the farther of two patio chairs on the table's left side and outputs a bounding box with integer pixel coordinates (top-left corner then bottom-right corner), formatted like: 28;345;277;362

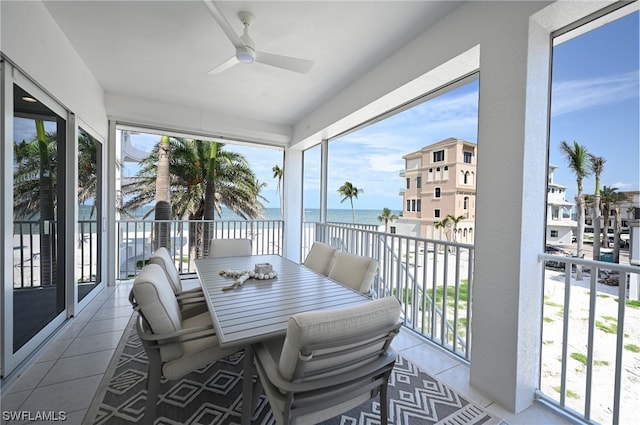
149;247;208;317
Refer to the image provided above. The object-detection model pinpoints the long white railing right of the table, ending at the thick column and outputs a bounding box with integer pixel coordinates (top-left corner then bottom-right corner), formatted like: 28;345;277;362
302;223;474;362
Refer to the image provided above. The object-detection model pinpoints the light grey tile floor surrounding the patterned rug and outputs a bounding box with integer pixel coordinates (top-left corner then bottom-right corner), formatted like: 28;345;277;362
0;282;571;425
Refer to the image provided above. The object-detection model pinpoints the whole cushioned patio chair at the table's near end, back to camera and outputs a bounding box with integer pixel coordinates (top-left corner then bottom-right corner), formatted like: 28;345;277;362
254;297;400;425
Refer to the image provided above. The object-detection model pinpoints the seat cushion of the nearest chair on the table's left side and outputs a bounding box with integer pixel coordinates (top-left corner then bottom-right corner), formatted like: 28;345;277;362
162;312;238;380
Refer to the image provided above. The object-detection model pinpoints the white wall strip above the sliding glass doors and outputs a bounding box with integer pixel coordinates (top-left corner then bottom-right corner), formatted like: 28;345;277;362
0;0;107;141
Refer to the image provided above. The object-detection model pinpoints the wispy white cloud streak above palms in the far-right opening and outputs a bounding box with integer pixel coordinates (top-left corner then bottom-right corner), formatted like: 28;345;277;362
551;71;638;116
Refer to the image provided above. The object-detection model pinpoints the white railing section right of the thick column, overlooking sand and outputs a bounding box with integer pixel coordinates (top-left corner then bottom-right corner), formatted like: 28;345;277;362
538;254;640;425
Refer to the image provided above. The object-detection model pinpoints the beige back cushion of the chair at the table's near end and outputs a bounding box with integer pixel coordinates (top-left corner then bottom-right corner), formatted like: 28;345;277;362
278;297;400;380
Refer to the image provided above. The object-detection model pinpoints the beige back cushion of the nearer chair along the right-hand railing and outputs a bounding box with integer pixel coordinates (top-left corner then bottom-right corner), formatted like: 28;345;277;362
328;251;378;294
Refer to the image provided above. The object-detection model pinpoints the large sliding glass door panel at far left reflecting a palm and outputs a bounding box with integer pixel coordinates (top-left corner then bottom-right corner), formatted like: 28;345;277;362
13;84;66;353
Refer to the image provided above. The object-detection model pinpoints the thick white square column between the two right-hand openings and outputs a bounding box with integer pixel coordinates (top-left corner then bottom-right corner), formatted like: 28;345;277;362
470;2;551;413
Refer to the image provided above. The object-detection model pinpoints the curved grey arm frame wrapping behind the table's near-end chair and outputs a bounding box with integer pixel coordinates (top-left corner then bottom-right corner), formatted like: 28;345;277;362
254;344;398;392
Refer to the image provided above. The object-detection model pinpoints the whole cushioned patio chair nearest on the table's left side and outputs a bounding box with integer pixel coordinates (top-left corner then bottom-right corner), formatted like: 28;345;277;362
129;264;237;424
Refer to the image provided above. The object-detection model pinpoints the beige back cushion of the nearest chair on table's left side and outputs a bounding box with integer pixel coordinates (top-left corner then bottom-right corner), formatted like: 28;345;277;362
132;264;182;361
